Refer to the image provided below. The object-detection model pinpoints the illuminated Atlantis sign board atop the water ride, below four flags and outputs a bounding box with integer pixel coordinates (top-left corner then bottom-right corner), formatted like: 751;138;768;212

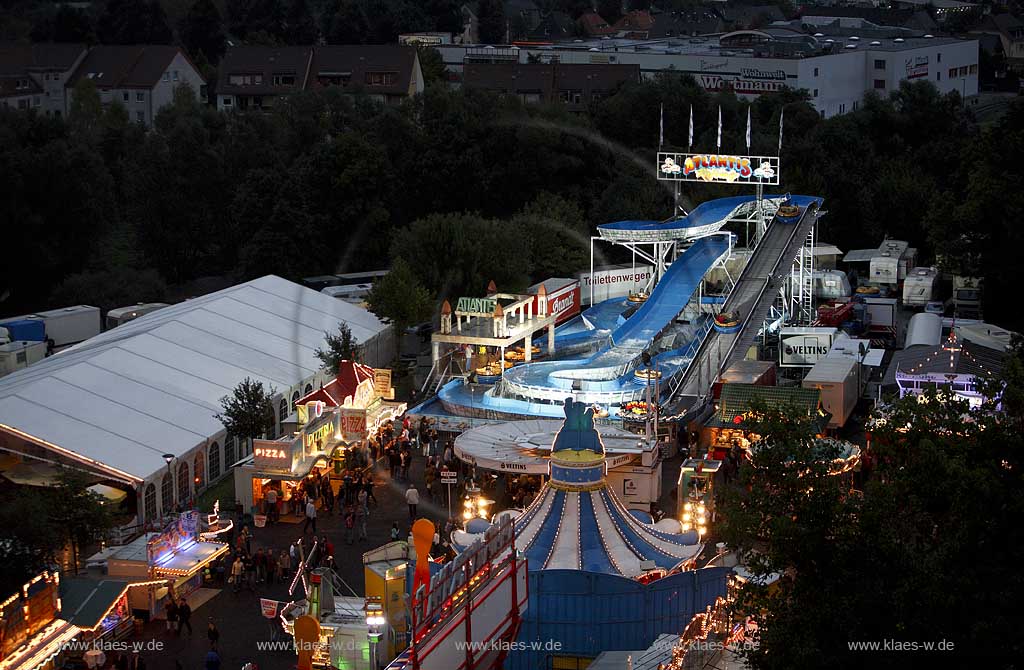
657;152;779;185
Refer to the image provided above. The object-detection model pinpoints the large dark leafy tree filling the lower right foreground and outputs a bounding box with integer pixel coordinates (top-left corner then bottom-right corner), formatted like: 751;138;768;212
720;370;1024;669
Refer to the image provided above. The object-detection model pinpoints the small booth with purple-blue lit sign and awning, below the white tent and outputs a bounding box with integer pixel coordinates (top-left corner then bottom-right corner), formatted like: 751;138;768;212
87;510;229;627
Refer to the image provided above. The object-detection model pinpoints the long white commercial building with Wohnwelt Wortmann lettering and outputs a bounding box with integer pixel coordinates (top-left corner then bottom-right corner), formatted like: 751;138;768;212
436;24;978;117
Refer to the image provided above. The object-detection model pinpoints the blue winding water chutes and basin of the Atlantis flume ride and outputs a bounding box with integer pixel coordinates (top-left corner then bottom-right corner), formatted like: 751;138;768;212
438;196;815;418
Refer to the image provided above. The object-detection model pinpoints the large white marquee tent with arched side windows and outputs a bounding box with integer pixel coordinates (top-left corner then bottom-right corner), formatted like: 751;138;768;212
0;276;393;522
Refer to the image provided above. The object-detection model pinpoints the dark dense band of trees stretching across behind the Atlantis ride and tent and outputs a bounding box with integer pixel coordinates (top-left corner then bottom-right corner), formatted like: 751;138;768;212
0;76;1024;326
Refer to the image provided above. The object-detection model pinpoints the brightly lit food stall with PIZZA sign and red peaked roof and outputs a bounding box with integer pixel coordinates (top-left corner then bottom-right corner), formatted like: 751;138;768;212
234;361;406;517
